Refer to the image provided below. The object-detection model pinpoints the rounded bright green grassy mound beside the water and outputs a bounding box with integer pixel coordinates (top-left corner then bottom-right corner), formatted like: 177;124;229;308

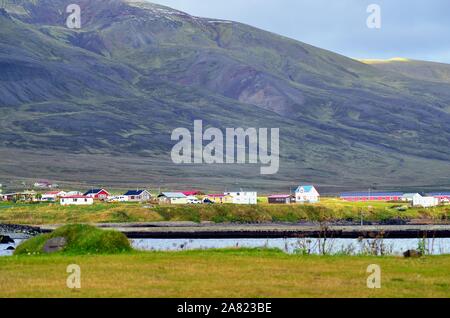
14;224;132;255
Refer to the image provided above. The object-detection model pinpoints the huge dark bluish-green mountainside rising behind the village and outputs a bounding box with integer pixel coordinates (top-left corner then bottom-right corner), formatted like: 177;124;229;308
0;0;450;193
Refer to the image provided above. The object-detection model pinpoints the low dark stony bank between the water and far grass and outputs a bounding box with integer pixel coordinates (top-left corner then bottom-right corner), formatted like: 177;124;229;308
40;222;450;239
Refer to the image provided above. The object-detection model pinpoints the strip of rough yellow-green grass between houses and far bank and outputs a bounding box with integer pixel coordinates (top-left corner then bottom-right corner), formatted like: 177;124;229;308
0;199;450;224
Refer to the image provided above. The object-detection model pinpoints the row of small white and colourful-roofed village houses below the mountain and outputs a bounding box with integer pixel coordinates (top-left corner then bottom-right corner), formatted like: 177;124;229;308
0;181;450;208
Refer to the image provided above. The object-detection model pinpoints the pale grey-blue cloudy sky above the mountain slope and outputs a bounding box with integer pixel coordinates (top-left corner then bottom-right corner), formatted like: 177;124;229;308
151;0;450;63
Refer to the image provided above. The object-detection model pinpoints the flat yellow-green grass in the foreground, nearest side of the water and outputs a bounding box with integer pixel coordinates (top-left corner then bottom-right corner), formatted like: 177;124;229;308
0;250;450;297
